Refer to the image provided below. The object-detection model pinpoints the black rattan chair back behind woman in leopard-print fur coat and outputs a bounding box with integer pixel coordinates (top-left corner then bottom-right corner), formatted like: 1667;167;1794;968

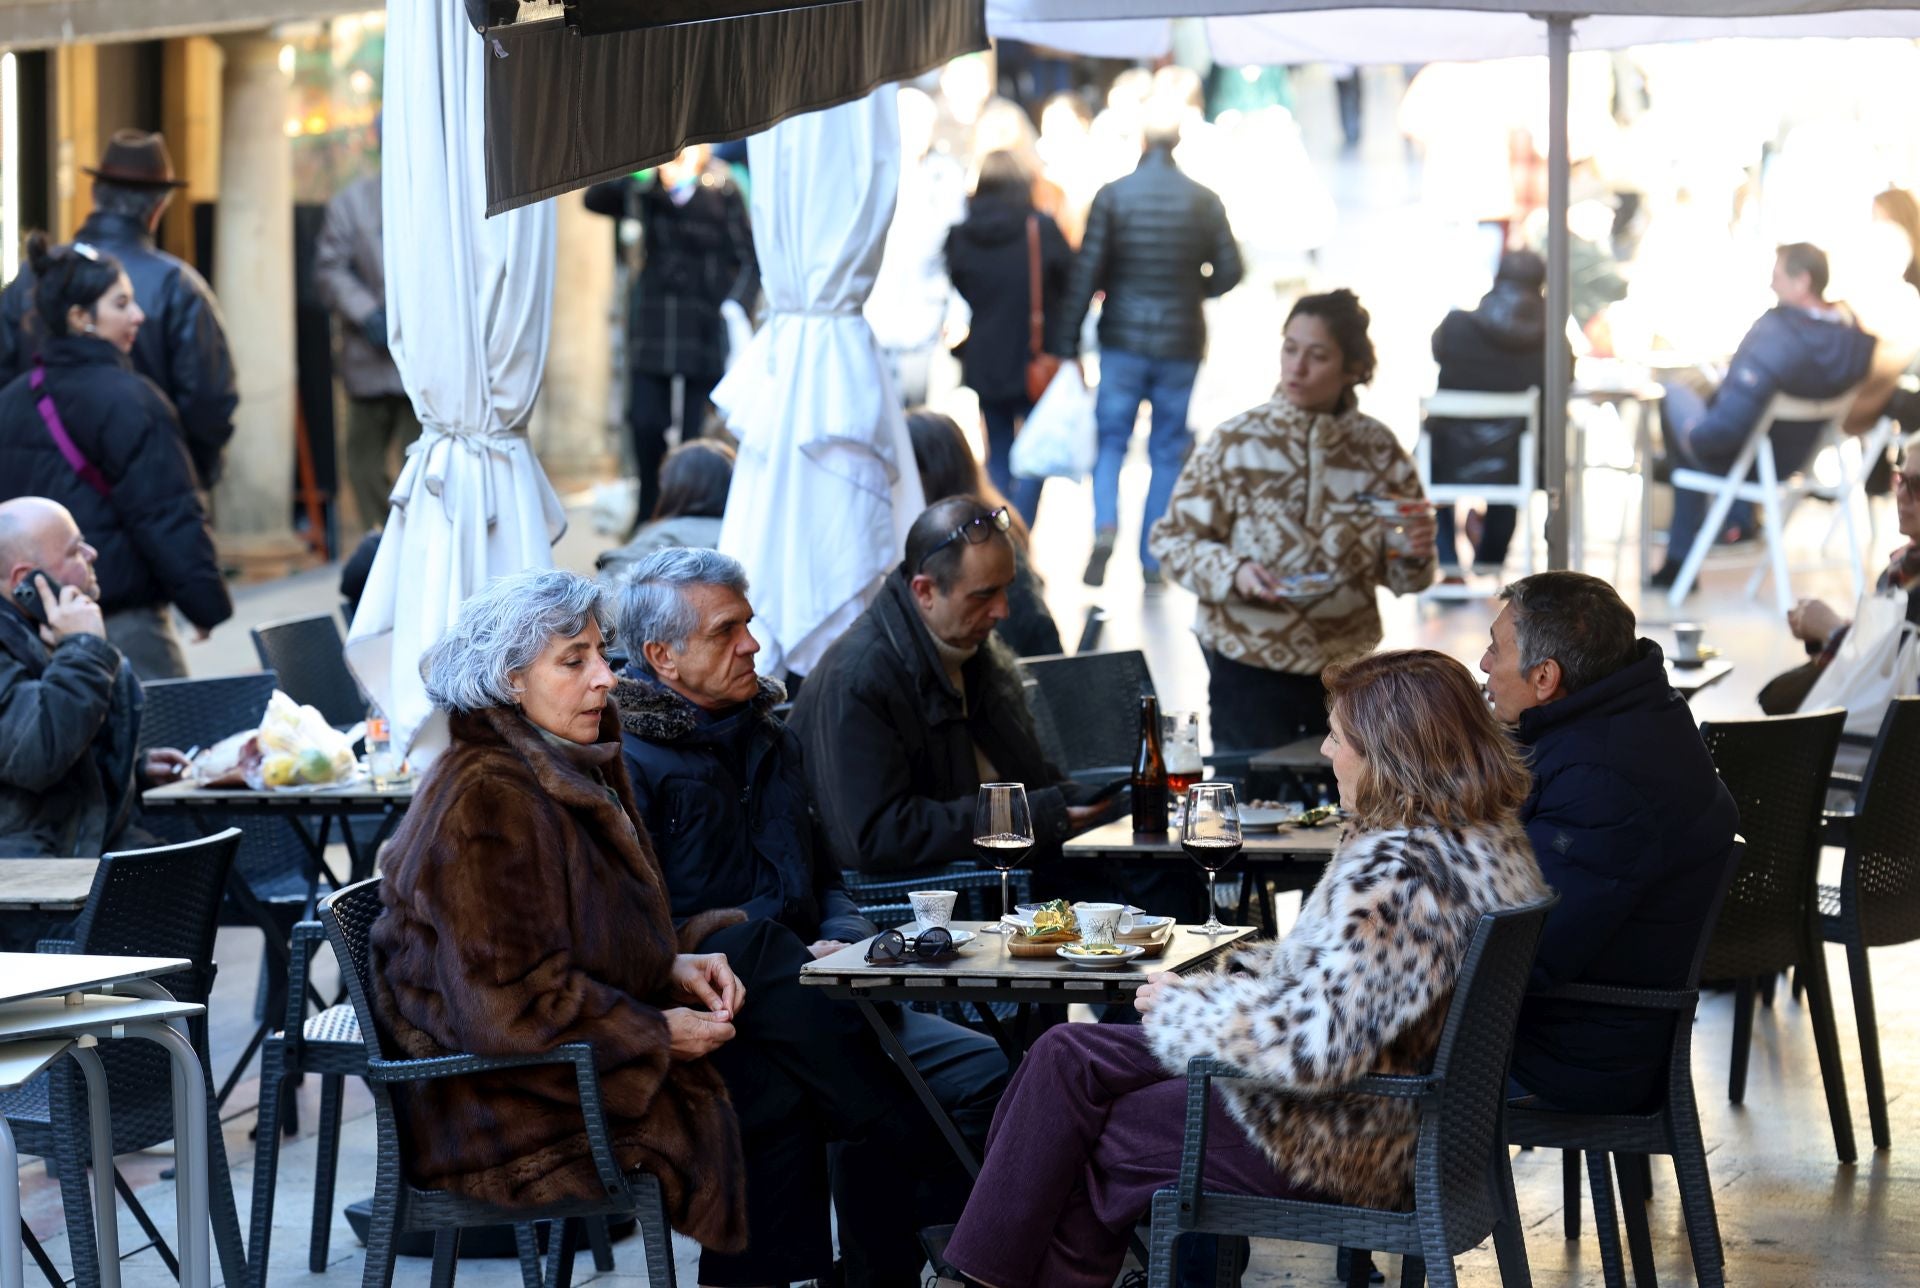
1413;894;1559;1253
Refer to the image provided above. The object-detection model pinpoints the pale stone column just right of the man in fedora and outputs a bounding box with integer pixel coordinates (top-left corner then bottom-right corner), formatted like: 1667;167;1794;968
213;33;305;576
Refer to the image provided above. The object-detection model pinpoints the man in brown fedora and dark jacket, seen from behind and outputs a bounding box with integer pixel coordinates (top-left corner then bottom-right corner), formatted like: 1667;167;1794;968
0;131;240;488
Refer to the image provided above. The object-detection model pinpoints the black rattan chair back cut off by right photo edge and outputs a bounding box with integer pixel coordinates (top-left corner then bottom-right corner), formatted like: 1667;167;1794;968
1841;697;1920;948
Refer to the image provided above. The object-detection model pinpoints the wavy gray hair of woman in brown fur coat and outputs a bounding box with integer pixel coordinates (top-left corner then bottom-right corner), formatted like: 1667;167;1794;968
420;568;614;710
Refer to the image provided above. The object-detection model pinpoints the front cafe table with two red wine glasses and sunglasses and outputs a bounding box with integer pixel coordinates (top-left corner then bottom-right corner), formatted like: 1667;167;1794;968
801;921;1254;1177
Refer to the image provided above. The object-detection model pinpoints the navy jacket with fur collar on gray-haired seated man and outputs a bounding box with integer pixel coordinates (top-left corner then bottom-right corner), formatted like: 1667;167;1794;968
614;666;874;942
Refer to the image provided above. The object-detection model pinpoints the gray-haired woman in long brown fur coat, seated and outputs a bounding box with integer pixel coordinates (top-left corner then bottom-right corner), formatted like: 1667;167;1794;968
372;572;747;1252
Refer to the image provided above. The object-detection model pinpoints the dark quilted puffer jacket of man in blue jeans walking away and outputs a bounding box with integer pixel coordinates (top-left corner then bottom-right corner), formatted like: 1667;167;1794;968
1060;148;1242;361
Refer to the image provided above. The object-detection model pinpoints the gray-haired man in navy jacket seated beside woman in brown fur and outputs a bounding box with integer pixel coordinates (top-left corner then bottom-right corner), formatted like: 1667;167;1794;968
614;547;1006;1284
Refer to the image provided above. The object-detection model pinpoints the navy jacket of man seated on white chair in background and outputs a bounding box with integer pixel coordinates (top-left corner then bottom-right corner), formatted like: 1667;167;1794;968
1686;305;1876;463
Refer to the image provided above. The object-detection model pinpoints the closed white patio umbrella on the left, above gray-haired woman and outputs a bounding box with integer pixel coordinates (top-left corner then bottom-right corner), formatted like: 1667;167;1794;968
348;4;566;764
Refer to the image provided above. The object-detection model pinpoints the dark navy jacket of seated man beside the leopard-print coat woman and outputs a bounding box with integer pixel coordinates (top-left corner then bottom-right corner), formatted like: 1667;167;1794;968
1513;639;1738;1111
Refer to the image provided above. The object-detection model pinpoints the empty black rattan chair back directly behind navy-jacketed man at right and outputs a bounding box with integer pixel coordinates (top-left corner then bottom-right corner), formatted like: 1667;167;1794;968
1699;710;1847;979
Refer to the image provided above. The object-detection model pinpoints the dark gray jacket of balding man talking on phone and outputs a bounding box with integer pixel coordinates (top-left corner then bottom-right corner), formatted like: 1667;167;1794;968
0;605;142;858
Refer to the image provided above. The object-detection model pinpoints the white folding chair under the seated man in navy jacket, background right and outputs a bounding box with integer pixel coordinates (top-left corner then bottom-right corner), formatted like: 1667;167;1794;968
1667;390;1866;614
